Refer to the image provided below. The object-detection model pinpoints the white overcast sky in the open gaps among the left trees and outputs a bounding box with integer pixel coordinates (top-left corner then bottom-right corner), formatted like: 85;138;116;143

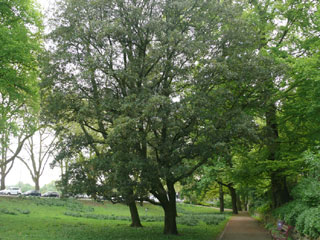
6;0;60;187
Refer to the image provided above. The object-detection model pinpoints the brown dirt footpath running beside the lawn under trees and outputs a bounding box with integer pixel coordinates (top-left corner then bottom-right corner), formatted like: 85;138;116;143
217;213;271;240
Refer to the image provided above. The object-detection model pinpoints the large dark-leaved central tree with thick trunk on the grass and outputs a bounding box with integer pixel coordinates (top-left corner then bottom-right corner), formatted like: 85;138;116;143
43;0;267;234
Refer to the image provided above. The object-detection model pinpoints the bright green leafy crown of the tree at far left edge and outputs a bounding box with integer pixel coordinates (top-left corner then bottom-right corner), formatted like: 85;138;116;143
0;0;42;102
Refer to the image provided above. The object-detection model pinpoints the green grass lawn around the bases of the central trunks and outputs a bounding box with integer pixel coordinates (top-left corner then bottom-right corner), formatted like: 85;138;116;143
0;197;229;240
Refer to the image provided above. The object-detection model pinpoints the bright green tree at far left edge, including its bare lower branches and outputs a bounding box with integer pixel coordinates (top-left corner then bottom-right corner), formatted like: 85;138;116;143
0;0;41;188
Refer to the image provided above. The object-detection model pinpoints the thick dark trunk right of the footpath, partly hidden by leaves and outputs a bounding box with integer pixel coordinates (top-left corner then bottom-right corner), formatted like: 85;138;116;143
266;104;290;208
